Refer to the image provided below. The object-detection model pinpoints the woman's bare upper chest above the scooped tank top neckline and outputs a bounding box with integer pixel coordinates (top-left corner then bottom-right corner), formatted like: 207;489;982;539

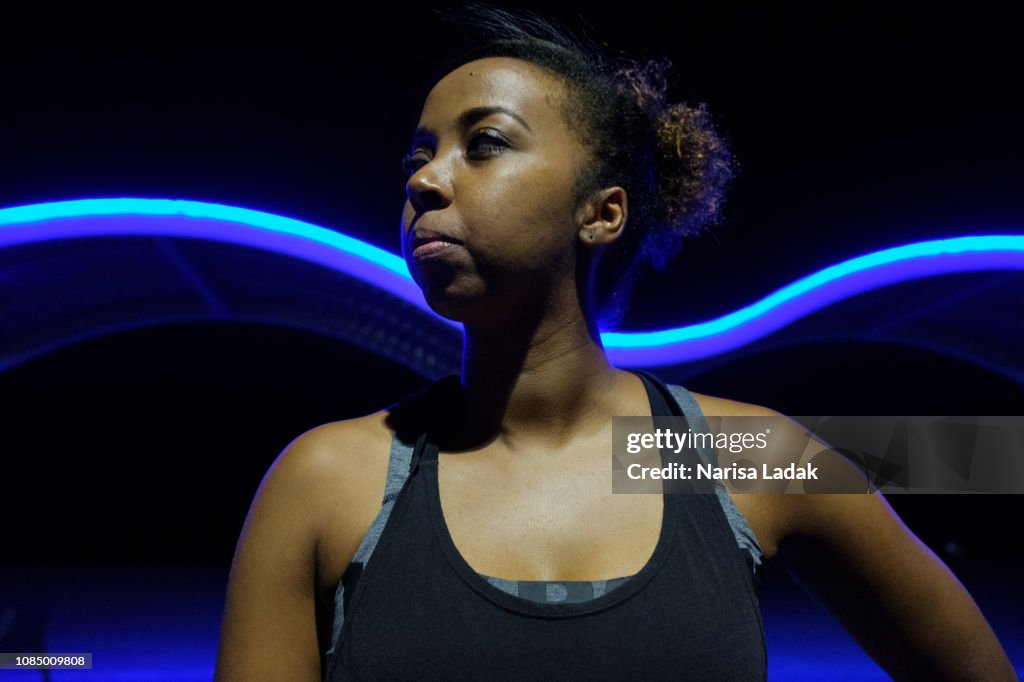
436;442;664;581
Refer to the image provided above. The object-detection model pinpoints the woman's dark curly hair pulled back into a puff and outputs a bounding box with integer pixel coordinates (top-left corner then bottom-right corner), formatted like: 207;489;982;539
428;3;738;330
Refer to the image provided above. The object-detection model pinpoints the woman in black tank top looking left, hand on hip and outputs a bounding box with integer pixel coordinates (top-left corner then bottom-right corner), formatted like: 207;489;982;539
211;8;1015;681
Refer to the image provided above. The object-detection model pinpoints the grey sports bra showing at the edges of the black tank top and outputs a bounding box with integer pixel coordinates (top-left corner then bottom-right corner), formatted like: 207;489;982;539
328;384;764;655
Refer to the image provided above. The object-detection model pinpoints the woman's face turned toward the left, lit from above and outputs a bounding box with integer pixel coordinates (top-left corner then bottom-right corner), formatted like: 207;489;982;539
402;57;586;319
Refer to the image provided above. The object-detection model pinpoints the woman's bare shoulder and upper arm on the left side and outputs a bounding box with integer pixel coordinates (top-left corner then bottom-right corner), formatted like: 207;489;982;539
215;405;387;682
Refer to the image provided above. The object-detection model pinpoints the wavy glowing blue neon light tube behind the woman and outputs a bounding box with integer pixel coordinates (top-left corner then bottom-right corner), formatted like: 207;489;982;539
0;199;1024;367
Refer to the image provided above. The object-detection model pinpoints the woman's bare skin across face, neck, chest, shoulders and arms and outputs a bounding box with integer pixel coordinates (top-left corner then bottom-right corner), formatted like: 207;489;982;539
215;58;1017;682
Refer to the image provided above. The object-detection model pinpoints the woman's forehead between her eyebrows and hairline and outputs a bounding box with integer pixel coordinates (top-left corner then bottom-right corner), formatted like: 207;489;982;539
420;57;565;129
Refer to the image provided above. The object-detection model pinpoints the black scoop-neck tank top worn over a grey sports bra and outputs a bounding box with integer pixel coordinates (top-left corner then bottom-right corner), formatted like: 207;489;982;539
325;372;767;681
